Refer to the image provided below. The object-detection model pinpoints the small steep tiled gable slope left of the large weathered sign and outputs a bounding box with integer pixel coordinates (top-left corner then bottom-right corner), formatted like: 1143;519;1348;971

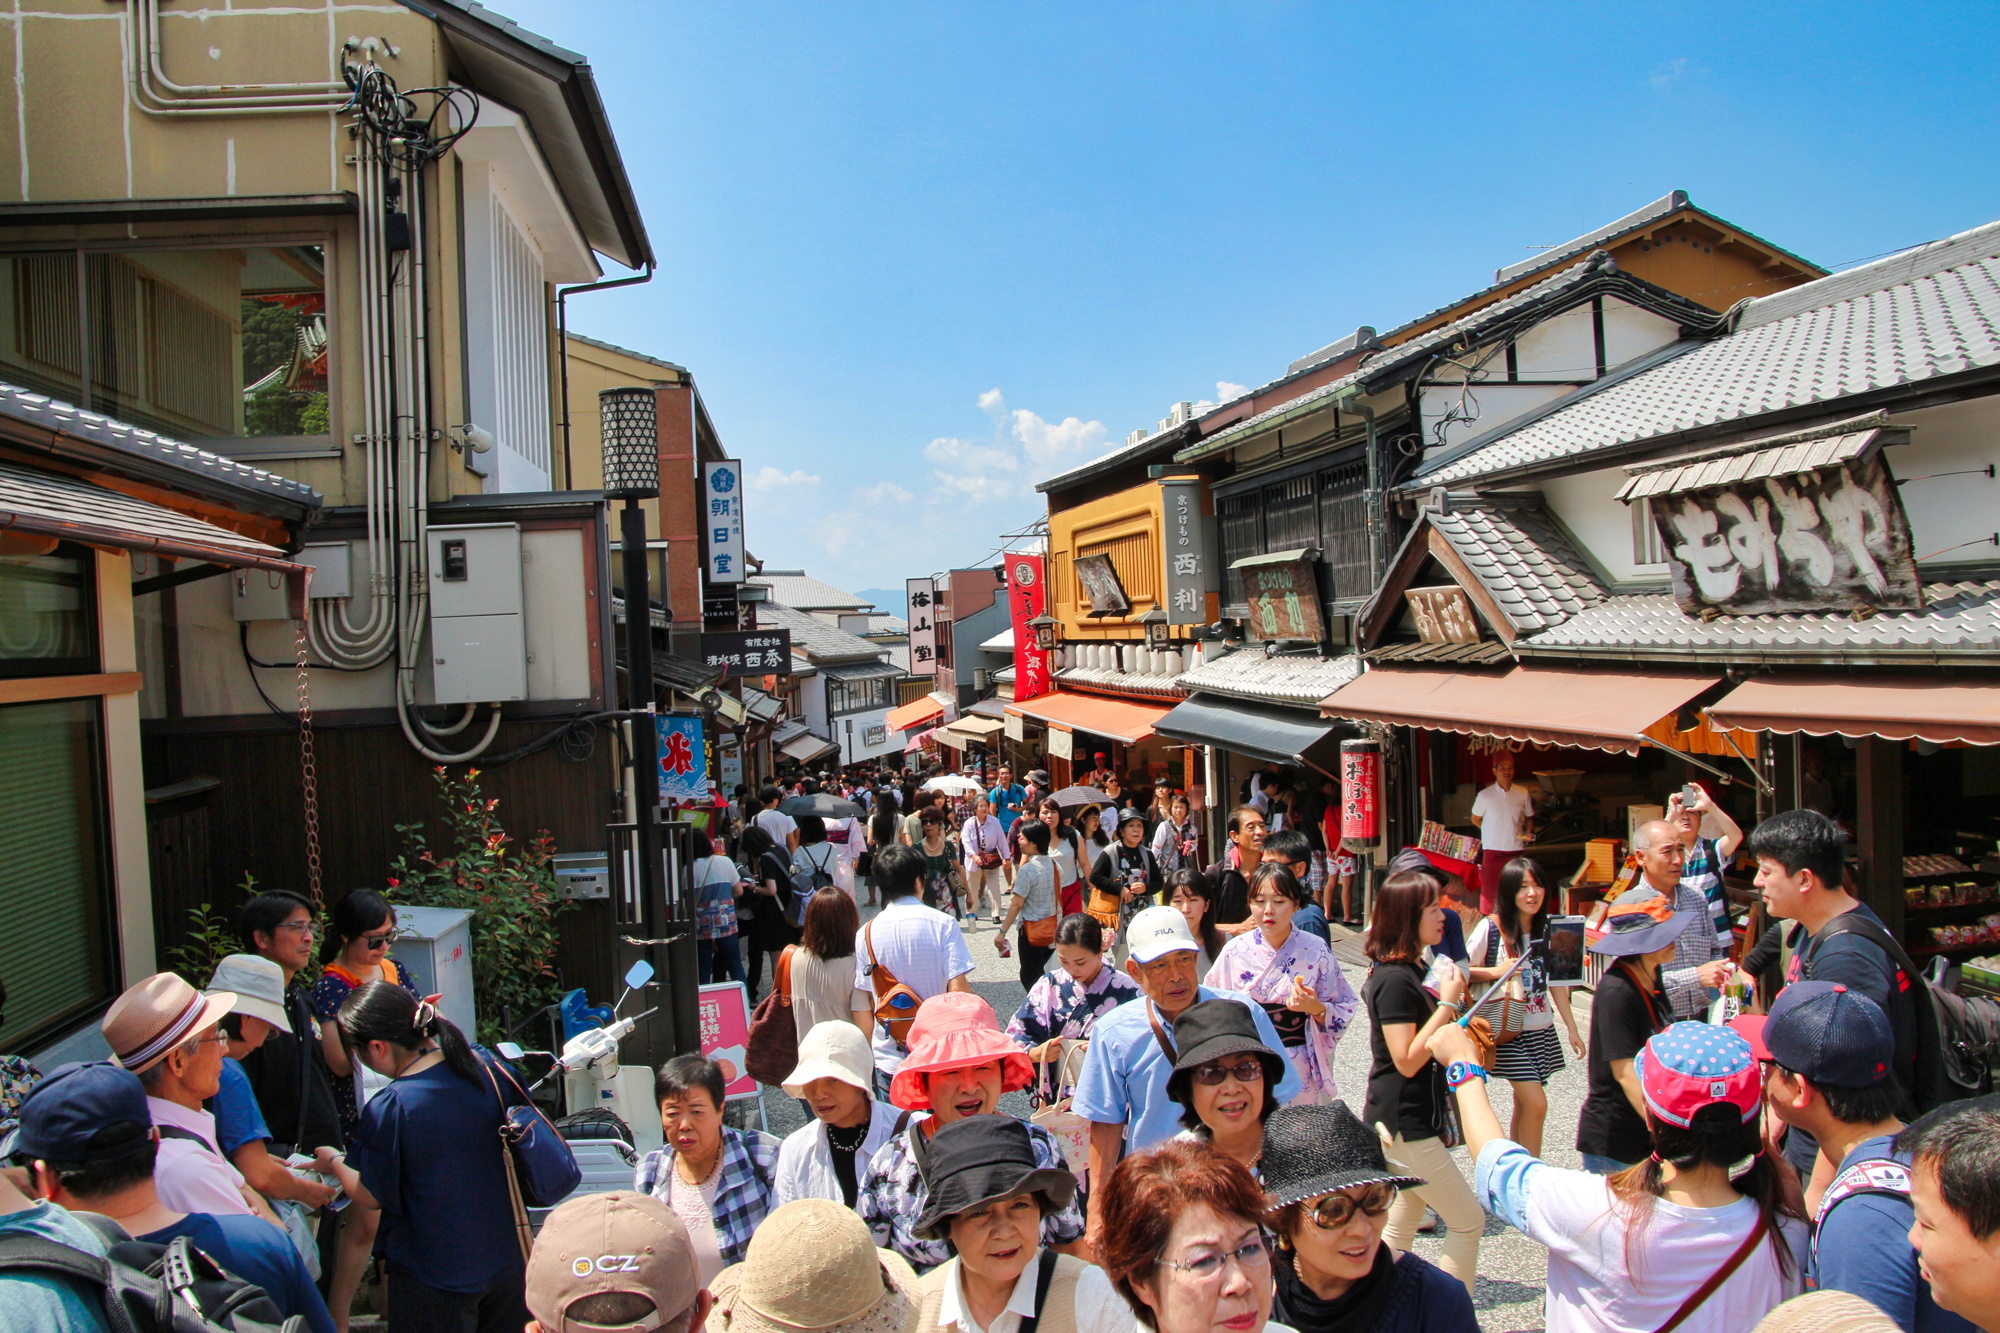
1424;500;1604;632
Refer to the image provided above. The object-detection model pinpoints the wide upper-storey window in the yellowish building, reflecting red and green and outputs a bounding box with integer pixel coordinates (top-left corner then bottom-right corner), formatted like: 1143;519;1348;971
0;244;332;440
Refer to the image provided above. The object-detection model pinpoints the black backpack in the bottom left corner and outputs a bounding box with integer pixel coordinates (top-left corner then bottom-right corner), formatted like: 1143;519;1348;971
0;1213;306;1333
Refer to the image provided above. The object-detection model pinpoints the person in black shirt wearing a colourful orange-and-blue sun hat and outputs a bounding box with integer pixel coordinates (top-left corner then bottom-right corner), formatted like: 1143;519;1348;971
1576;899;1702;1175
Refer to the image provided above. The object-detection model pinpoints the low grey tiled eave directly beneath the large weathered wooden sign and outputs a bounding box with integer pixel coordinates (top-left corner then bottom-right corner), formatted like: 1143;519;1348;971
1514;580;2000;667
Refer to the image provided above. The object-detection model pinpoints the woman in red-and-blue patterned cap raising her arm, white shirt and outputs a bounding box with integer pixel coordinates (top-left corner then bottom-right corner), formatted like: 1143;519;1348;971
1430;1023;1806;1333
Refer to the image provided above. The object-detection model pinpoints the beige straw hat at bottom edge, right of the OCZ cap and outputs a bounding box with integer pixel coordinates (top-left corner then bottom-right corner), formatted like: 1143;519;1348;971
708;1199;922;1333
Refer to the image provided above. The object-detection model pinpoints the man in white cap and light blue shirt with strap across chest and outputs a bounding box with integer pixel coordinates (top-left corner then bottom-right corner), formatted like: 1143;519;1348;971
1070;907;1298;1237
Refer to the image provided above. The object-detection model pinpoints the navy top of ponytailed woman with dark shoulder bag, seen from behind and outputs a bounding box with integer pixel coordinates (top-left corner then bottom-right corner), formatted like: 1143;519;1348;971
348;1065;524;1293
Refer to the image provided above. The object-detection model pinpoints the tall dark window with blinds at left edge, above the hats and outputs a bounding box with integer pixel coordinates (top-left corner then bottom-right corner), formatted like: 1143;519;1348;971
0;699;116;1051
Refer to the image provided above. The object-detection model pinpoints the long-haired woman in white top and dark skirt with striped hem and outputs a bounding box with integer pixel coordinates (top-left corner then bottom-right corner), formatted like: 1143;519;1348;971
1466;857;1584;1157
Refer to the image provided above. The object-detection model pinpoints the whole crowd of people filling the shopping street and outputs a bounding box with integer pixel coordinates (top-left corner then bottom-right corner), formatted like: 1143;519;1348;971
0;748;2000;1333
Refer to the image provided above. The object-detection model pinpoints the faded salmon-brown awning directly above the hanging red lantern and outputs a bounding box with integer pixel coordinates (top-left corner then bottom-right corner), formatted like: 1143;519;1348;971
1320;667;1720;755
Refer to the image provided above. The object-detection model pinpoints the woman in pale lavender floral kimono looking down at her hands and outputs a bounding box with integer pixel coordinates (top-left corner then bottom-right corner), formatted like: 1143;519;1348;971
1202;860;1360;1101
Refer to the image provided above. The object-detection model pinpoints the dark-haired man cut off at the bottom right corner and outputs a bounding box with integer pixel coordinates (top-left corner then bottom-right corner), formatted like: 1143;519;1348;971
1894;1097;2000;1331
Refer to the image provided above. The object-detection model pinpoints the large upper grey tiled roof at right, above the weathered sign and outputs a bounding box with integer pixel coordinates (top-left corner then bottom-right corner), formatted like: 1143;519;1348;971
1412;222;2000;486
